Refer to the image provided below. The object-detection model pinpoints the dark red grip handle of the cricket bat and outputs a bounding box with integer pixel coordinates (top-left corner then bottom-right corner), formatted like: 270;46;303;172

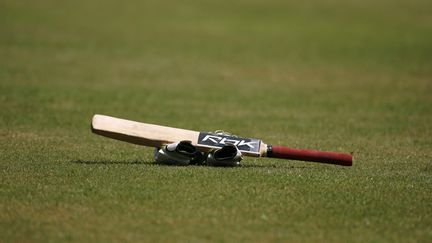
267;146;352;166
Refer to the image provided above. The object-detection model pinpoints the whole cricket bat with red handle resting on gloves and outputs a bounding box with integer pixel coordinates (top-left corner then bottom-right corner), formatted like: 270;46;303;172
91;114;352;166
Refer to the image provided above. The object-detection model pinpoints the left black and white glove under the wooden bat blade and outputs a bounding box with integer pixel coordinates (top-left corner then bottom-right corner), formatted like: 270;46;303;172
155;141;205;165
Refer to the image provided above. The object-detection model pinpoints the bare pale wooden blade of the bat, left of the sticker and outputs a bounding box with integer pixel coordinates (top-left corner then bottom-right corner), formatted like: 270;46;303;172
91;115;199;147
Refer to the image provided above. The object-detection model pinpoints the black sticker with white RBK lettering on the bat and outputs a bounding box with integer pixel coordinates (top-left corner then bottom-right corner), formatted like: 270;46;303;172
198;132;261;153
